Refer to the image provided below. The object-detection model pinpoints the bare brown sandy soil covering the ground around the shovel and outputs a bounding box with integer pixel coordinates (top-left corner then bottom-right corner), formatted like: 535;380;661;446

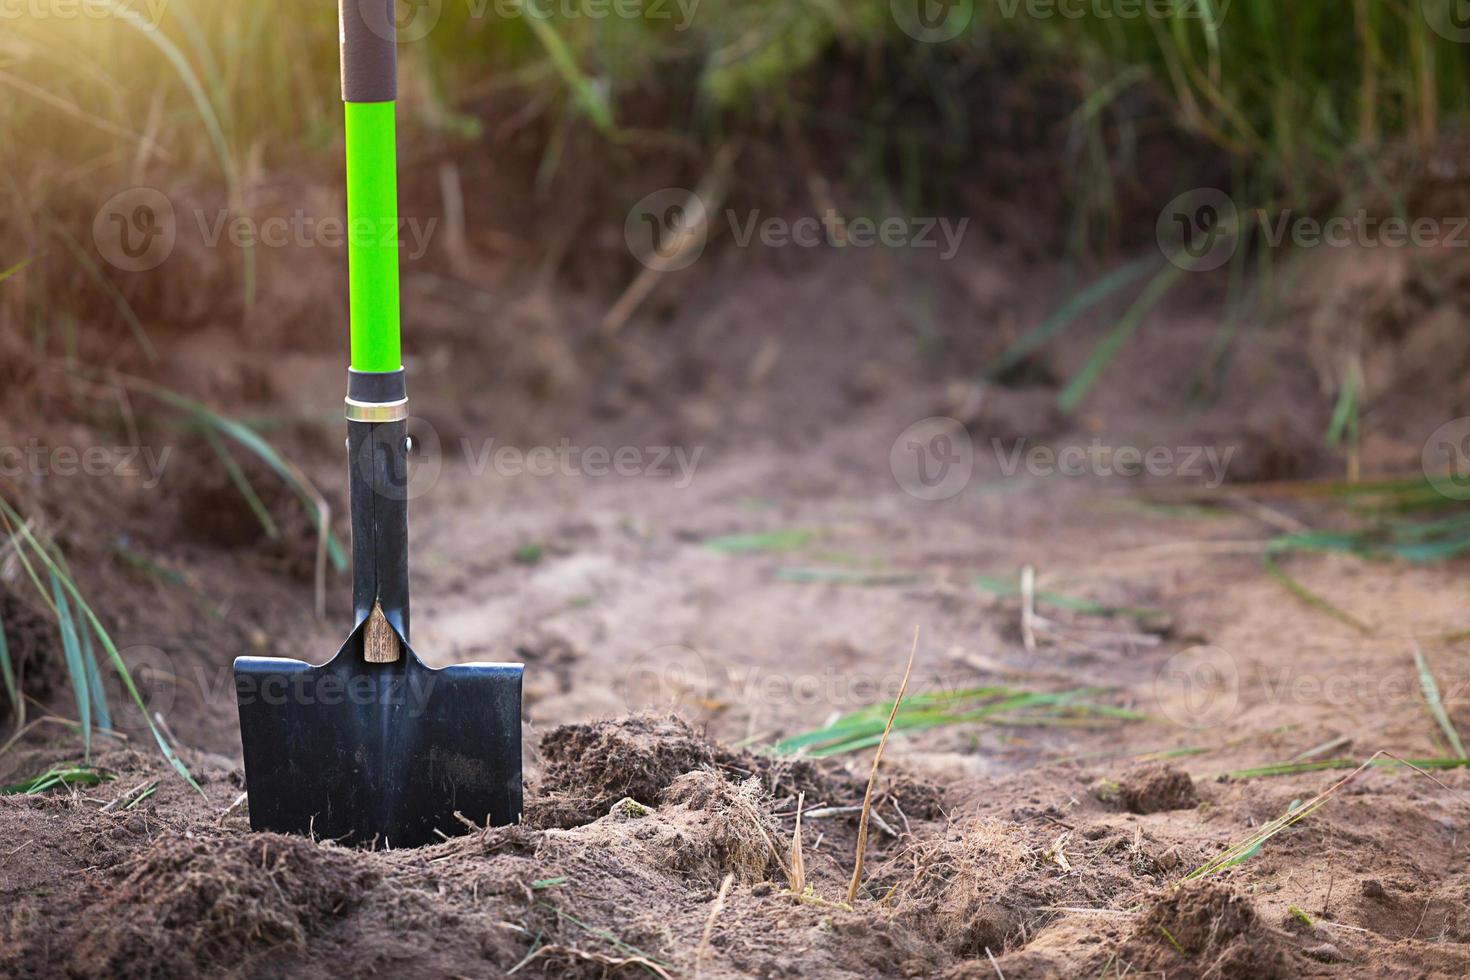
0;157;1470;980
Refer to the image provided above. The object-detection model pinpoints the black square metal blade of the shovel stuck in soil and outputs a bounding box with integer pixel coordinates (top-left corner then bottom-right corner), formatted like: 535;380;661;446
235;636;522;848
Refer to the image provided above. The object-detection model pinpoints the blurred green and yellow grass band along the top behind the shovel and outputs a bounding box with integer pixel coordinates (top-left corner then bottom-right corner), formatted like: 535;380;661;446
0;0;1470;262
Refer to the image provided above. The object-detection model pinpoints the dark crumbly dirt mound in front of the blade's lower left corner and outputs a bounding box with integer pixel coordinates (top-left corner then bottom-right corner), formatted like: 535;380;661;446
71;835;378;977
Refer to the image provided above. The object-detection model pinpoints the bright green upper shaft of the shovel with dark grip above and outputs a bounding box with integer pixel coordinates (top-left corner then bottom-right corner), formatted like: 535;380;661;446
338;0;403;372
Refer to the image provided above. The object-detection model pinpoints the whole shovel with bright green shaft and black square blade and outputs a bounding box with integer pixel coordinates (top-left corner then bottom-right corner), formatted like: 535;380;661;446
235;0;522;848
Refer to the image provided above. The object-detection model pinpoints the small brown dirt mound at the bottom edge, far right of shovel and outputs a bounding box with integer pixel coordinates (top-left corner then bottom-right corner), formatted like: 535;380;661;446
1127;883;1297;980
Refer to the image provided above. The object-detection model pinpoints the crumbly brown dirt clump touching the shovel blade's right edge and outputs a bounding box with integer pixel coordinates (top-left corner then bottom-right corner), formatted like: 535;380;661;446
526;714;714;827
